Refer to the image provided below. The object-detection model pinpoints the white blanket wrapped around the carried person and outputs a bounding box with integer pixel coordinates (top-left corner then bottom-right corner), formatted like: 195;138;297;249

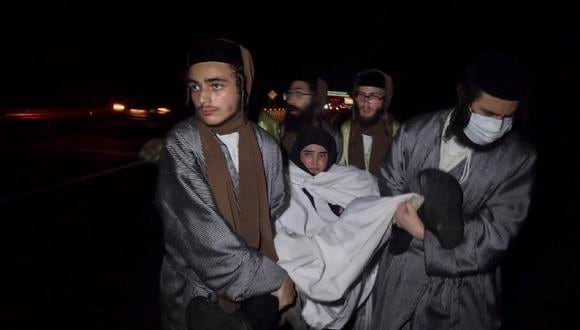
274;162;421;329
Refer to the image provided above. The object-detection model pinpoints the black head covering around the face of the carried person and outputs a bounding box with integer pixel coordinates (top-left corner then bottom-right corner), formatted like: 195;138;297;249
289;127;337;173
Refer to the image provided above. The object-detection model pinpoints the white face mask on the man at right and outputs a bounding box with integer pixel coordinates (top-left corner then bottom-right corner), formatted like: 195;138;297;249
463;109;512;145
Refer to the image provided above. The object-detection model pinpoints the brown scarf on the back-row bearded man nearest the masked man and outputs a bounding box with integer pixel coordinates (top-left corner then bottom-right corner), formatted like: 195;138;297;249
348;120;393;177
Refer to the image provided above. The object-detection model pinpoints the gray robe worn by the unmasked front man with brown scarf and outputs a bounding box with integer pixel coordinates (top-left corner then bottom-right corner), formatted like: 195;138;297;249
156;118;286;330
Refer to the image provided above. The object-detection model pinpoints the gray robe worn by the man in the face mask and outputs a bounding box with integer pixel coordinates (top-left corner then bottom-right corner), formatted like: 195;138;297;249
372;110;536;330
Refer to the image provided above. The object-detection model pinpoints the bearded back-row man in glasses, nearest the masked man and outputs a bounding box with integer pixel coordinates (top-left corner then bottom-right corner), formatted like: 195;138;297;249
339;69;399;177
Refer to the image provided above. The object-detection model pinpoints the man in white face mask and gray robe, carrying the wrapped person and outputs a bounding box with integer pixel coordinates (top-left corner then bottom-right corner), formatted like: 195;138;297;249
372;54;536;329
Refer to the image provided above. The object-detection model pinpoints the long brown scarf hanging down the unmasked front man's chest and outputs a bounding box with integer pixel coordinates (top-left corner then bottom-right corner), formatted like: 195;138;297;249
198;111;278;312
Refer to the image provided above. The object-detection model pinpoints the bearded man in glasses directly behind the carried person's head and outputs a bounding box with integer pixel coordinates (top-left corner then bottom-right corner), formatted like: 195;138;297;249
258;72;342;160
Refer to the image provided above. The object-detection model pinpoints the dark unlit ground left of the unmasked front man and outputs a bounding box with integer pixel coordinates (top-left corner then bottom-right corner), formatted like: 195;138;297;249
0;119;162;329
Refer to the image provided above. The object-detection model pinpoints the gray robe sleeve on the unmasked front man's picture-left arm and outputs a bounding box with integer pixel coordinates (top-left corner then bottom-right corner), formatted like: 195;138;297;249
157;127;285;301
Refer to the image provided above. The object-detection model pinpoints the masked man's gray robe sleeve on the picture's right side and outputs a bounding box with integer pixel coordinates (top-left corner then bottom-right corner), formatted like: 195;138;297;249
423;153;536;277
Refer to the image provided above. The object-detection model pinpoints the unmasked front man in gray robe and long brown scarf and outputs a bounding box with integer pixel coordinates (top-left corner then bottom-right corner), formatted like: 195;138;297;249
157;39;295;330
